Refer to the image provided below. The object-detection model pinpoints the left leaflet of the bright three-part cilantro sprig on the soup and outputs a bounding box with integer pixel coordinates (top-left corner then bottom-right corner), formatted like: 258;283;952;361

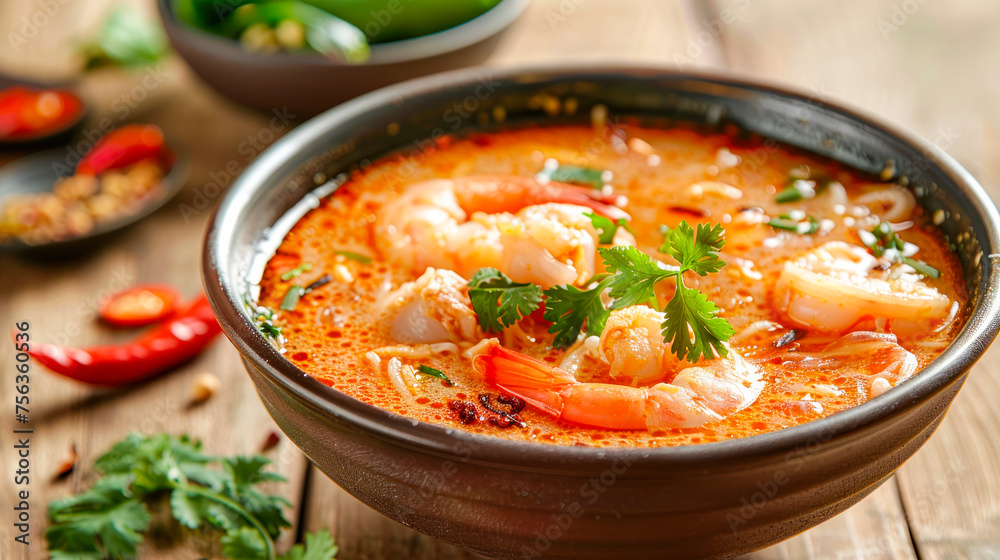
597;245;680;309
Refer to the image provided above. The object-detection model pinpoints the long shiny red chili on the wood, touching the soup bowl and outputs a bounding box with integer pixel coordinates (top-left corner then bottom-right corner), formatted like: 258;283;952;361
28;294;222;387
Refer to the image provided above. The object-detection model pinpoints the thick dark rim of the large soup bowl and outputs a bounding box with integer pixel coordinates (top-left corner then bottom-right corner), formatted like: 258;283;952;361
203;61;1000;472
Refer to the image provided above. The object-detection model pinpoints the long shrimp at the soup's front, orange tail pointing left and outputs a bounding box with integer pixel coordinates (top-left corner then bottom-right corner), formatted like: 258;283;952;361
472;339;764;430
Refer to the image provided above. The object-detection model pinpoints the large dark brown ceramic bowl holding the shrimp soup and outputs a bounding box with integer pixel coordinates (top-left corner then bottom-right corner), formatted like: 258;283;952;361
204;65;1000;558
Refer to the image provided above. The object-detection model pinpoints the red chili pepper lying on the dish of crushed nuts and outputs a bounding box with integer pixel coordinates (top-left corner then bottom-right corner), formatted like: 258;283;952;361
76;124;173;175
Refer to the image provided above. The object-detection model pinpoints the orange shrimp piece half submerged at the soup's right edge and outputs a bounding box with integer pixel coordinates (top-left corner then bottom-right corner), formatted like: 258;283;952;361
782;331;917;398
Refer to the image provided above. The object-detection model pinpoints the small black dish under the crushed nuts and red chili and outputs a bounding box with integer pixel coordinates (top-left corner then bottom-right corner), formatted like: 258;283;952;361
0;149;190;260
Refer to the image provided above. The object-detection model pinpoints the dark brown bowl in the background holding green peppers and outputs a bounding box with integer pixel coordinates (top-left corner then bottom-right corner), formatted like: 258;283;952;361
157;0;530;118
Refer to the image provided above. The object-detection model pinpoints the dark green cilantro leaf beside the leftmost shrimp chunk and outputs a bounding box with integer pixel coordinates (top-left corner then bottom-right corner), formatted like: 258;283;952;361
469;268;542;332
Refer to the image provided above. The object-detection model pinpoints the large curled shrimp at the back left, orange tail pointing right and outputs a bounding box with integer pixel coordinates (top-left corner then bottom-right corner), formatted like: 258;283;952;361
377;175;628;287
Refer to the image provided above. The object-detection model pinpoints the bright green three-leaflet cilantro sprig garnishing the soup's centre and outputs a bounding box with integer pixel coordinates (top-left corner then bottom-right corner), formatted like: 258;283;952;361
598;222;736;362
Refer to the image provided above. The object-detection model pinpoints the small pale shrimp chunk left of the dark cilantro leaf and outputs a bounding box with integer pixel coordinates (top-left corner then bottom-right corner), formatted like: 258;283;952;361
376;268;480;344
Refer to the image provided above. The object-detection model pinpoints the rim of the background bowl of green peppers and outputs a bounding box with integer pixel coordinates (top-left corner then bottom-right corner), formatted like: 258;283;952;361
157;0;531;67
